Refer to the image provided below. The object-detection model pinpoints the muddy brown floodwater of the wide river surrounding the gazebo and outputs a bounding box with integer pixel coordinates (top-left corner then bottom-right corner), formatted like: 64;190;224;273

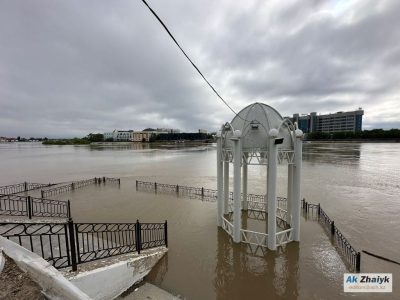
0;143;400;299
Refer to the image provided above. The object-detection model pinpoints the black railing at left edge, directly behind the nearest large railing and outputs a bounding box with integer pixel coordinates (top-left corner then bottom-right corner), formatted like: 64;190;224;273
0;195;71;219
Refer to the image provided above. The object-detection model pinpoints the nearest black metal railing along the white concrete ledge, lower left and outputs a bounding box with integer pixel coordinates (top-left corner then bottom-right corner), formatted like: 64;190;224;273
0;219;168;271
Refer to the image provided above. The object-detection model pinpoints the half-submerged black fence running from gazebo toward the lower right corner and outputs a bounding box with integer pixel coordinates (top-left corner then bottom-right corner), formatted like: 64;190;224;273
301;199;361;271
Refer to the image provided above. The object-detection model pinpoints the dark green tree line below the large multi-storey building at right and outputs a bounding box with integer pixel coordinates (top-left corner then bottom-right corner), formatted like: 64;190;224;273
307;129;400;140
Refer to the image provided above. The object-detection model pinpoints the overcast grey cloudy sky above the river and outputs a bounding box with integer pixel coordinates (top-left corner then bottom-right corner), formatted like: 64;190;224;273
0;0;400;137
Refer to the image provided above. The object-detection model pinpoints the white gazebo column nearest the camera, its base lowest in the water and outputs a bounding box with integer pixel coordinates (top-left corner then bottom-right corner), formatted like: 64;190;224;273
268;128;278;250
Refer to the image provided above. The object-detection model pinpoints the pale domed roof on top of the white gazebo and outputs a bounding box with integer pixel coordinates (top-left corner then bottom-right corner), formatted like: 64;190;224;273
223;102;293;149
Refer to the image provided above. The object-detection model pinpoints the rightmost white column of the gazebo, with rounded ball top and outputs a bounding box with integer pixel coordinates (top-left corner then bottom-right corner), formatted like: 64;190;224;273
292;129;303;242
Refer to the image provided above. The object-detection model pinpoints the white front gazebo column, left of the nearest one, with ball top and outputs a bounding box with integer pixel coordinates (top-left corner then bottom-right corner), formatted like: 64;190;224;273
231;130;242;243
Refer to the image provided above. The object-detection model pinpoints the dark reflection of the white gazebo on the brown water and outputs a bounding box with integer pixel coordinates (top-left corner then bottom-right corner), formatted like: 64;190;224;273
212;228;299;300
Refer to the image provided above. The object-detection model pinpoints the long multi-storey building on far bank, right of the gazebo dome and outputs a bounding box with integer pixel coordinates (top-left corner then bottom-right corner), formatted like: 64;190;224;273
289;108;364;133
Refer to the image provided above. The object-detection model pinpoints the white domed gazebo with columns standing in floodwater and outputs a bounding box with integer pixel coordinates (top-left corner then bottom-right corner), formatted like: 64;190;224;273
217;103;303;250
